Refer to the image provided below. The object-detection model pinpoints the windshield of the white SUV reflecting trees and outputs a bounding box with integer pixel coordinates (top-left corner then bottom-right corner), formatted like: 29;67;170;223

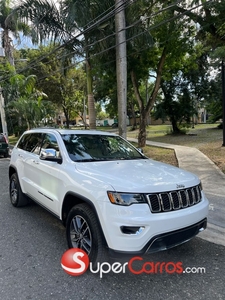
62;134;145;162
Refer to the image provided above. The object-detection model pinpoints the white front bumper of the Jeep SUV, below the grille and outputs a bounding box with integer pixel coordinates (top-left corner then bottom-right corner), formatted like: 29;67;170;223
98;193;209;254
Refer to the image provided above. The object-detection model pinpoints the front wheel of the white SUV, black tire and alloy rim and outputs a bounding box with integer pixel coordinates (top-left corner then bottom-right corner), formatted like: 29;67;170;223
66;203;108;267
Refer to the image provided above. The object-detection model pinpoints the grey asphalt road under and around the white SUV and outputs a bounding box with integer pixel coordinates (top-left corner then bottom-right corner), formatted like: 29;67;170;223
0;159;225;300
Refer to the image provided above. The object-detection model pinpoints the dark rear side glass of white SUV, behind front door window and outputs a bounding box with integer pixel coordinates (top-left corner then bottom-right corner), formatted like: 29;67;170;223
17;133;42;154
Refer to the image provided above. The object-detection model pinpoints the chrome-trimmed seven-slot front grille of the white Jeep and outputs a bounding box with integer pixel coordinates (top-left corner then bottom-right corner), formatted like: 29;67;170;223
147;185;201;213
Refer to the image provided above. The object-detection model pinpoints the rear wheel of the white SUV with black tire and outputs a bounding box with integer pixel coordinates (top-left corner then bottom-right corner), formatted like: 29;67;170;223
9;173;29;207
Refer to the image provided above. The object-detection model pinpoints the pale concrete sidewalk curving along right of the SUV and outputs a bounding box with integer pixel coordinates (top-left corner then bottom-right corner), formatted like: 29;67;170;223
128;138;225;246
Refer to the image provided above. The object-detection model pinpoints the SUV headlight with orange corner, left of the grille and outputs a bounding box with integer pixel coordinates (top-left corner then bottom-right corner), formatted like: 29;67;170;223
107;192;146;206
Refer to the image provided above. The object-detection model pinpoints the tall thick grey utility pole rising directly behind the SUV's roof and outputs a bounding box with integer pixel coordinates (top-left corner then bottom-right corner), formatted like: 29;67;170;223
115;0;127;138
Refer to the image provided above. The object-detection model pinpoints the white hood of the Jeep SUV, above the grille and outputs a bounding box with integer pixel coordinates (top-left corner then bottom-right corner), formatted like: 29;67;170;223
76;159;199;193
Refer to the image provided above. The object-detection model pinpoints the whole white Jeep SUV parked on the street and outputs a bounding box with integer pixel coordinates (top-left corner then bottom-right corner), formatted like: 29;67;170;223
9;128;208;263
